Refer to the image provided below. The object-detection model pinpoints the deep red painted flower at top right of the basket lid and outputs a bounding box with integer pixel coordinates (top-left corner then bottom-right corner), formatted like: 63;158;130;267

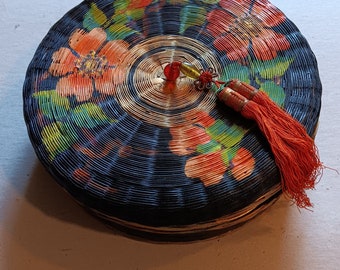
207;0;290;61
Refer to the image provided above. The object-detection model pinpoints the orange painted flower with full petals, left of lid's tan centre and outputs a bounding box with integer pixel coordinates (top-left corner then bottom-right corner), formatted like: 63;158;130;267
49;28;128;102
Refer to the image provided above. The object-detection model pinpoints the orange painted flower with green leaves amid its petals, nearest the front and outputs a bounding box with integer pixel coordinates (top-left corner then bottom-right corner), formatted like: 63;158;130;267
169;111;255;186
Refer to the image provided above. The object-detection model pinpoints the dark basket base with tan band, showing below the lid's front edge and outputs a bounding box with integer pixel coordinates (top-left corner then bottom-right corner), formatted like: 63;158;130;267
90;185;282;243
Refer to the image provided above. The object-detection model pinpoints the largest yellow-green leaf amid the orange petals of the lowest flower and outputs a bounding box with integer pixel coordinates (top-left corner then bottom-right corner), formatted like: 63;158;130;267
207;119;245;148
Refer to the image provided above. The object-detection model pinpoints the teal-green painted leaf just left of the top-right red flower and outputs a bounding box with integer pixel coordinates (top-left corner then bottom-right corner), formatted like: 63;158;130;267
180;5;207;34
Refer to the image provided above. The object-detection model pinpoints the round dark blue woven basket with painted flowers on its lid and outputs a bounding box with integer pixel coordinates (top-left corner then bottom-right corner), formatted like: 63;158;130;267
23;0;322;241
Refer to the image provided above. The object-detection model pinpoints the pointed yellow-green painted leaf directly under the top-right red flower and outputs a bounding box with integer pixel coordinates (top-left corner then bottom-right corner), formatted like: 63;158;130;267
251;56;294;80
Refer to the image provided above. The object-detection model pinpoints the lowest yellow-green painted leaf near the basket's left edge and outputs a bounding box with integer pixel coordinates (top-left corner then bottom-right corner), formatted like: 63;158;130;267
41;122;77;160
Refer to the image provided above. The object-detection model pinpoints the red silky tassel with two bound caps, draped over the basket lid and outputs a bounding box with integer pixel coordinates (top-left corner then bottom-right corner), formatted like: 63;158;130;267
217;85;323;208
